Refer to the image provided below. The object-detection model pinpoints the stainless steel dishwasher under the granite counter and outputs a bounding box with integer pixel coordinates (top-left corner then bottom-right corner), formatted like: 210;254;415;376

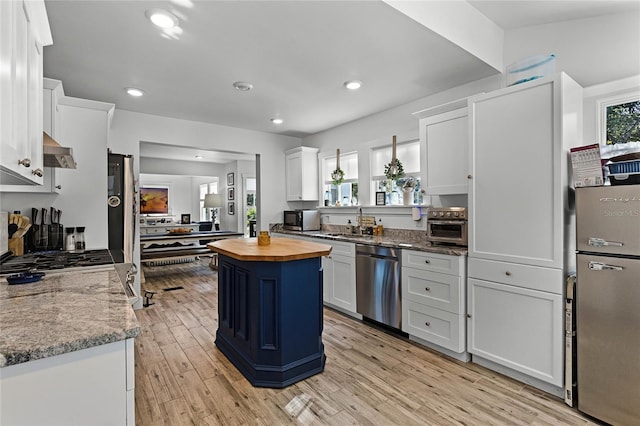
356;244;402;329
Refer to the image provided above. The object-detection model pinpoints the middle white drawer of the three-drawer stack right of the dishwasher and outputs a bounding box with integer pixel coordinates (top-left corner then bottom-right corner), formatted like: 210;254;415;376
402;267;464;314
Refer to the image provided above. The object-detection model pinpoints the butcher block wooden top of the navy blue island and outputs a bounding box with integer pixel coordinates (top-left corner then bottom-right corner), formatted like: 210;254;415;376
207;237;331;262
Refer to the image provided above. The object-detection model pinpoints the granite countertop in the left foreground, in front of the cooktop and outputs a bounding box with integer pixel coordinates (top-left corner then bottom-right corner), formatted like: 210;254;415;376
0;269;140;367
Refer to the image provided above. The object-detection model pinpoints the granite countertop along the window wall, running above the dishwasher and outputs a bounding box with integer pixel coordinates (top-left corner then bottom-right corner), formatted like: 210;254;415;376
272;227;468;256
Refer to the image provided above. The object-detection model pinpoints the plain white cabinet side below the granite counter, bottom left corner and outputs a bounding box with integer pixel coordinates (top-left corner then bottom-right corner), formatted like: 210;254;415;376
0;339;135;425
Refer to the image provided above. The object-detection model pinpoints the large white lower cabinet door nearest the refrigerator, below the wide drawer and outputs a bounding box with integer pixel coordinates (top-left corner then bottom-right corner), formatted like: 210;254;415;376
467;278;564;386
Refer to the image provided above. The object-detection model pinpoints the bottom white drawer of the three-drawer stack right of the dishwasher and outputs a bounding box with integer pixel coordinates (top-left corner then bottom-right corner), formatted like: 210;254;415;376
402;301;465;353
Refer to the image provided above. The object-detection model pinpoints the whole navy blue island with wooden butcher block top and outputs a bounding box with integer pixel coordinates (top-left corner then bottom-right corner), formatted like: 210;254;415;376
207;238;331;388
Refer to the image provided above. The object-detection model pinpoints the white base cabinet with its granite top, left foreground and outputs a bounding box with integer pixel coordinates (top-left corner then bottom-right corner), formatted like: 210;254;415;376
0;266;140;425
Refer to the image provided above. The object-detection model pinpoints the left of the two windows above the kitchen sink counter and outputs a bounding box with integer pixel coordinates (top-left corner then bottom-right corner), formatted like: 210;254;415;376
321;151;358;207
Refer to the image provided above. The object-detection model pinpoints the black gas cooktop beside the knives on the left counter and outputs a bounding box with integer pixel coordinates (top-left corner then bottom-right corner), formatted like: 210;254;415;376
0;249;113;275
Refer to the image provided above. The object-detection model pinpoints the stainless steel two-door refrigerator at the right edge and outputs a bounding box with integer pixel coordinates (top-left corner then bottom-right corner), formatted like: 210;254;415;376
575;185;640;425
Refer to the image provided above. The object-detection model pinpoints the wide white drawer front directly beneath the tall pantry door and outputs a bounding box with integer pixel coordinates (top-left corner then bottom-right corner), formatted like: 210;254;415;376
469;258;564;294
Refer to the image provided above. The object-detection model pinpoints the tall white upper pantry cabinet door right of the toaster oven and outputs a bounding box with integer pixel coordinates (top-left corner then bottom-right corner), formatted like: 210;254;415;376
469;78;566;267
